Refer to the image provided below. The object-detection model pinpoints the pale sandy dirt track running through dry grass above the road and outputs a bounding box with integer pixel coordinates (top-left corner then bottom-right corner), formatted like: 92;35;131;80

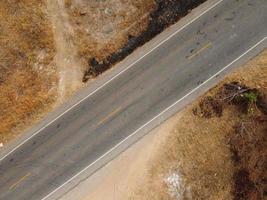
46;0;83;102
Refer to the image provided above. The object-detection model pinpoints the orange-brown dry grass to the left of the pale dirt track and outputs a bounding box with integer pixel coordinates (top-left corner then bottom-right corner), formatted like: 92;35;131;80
0;0;57;143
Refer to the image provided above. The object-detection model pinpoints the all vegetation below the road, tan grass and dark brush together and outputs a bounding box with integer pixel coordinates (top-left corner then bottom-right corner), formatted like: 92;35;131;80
132;50;267;200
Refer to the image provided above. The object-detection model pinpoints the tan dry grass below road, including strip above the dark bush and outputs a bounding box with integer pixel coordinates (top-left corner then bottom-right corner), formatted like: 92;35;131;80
132;50;267;200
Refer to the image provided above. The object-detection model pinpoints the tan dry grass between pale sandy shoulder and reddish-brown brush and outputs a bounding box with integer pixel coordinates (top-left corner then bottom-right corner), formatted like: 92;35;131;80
133;107;235;200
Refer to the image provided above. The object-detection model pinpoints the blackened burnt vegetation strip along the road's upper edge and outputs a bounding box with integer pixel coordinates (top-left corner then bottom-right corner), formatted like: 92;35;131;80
83;0;206;82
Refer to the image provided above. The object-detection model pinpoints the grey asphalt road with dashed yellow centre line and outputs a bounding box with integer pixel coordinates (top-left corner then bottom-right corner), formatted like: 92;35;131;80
0;0;267;200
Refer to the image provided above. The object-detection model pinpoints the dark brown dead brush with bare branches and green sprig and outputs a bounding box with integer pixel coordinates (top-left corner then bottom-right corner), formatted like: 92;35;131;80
195;82;267;200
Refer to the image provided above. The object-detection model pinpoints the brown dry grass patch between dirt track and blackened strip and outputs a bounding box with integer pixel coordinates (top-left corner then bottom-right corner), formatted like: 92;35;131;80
65;0;155;64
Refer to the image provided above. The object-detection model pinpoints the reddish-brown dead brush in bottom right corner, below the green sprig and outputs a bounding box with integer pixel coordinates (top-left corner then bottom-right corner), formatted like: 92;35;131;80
230;115;267;200
